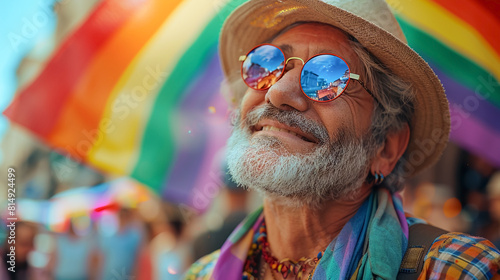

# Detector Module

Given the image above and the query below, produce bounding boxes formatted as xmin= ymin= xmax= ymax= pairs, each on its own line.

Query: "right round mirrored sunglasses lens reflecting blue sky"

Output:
xmin=300 ymin=54 xmax=349 ymax=101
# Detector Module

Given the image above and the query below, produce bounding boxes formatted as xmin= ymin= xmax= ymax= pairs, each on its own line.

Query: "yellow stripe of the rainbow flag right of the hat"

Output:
xmin=387 ymin=0 xmax=500 ymax=79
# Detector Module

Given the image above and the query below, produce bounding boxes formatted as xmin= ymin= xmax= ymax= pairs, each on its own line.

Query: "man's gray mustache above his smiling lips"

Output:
xmin=245 ymin=104 xmax=330 ymax=144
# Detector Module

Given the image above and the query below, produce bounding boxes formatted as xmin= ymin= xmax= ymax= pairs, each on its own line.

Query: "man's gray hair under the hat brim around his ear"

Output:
xmin=348 ymin=36 xmax=415 ymax=192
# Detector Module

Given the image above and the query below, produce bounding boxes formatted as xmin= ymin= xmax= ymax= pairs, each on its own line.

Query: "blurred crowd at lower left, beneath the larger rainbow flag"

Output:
xmin=0 ymin=189 xmax=254 ymax=280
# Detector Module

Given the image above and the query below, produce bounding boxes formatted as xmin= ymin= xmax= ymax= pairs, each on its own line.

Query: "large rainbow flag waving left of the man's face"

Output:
xmin=4 ymin=0 xmax=243 ymax=211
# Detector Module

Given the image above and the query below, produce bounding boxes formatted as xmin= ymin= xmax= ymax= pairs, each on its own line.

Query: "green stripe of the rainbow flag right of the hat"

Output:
xmin=396 ymin=16 xmax=500 ymax=108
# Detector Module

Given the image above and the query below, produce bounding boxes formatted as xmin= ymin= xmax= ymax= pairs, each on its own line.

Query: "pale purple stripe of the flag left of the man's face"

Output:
xmin=163 ymin=51 xmax=230 ymax=211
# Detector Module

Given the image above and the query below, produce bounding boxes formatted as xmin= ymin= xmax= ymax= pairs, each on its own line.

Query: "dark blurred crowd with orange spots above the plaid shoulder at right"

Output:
xmin=403 ymin=144 xmax=500 ymax=248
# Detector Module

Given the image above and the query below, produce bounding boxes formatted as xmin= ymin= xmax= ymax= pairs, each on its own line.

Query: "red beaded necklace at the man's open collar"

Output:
xmin=242 ymin=220 xmax=323 ymax=280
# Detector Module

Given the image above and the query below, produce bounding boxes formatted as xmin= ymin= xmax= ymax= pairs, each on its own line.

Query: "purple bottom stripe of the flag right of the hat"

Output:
xmin=450 ymin=104 xmax=500 ymax=167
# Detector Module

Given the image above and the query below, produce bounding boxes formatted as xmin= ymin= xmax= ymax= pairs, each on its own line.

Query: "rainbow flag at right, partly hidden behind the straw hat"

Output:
xmin=387 ymin=0 xmax=500 ymax=167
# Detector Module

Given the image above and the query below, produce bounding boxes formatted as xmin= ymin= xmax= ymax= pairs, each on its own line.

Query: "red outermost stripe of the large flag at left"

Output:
xmin=4 ymin=0 xmax=145 ymax=138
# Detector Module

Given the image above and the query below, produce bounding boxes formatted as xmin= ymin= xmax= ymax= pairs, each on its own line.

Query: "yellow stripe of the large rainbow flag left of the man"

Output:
xmin=88 ymin=0 xmax=221 ymax=174
